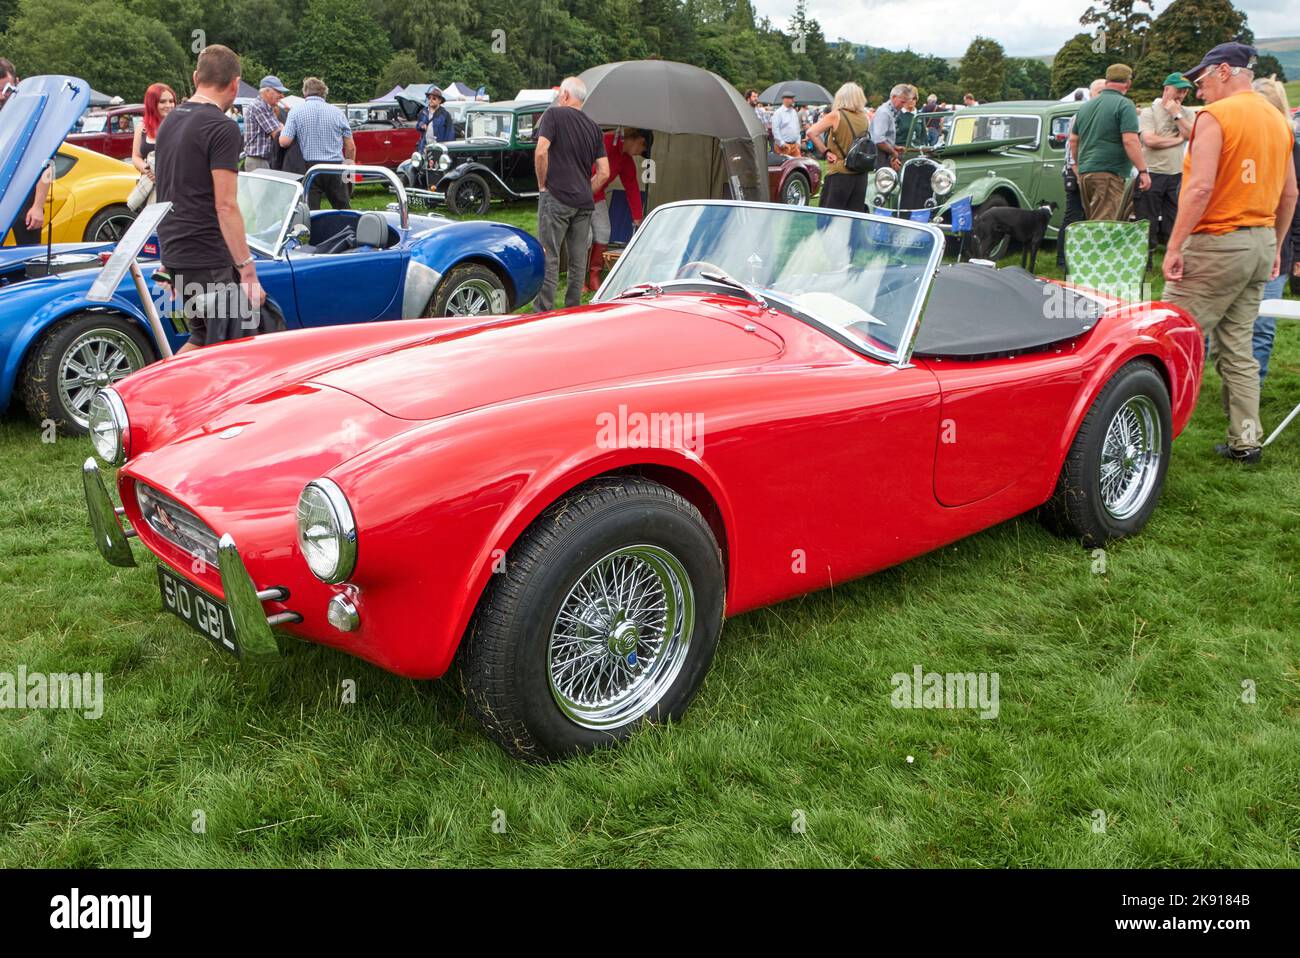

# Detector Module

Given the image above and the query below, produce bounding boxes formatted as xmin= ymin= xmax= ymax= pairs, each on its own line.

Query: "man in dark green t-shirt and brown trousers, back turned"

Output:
xmin=1070 ymin=64 xmax=1151 ymax=220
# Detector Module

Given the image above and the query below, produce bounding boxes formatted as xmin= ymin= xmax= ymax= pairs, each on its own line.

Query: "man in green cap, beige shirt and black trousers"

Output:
xmin=1134 ymin=73 xmax=1196 ymax=250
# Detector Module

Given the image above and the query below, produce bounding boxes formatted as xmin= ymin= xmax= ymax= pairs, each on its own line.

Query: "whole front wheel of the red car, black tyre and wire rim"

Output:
xmin=462 ymin=477 xmax=725 ymax=762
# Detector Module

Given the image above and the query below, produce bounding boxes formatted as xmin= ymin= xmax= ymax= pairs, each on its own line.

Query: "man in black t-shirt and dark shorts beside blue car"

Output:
xmin=155 ymin=44 xmax=265 ymax=352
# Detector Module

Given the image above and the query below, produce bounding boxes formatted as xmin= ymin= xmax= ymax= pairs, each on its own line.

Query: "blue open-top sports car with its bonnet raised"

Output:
xmin=0 ymin=77 xmax=545 ymax=433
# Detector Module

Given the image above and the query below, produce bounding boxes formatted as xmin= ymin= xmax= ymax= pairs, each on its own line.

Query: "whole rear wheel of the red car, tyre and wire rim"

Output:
xmin=1048 ymin=363 xmax=1173 ymax=547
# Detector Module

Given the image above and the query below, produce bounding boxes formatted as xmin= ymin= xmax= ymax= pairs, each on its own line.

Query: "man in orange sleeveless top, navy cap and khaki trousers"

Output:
xmin=1165 ymin=43 xmax=1296 ymax=463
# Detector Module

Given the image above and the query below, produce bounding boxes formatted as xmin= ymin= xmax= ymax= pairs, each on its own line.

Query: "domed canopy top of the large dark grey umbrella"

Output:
xmin=580 ymin=60 xmax=764 ymax=139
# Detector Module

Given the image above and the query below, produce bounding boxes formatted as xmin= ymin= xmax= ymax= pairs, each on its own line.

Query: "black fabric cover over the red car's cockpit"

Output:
xmin=913 ymin=263 xmax=1104 ymax=359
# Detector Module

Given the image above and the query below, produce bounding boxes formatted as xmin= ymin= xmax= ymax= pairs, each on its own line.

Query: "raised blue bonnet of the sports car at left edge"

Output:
xmin=0 ymin=77 xmax=90 ymax=231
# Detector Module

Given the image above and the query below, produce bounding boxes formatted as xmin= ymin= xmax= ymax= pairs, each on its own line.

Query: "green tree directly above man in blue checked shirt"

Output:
xmin=280 ymin=0 xmax=393 ymax=101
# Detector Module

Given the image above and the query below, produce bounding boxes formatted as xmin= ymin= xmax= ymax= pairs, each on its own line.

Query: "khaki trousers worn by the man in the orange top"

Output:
xmin=1165 ymin=226 xmax=1278 ymax=450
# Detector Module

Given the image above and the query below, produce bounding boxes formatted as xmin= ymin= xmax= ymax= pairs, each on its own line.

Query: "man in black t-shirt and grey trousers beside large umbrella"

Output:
xmin=533 ymin=77 xmax=610 ymax=313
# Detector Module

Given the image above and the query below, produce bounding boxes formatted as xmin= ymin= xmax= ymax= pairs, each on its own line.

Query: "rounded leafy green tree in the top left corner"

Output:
xmin=5 ymin=0 xmax=192 ymax=100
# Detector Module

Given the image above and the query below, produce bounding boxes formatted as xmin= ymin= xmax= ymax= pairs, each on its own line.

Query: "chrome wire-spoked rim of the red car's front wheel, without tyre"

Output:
xmin=546 ymin=545 xmax=696 ymax=729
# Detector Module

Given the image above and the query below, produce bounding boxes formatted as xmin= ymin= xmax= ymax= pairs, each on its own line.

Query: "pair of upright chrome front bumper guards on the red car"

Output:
xmin=82 ymin=459 xmax=292 ymax=658
